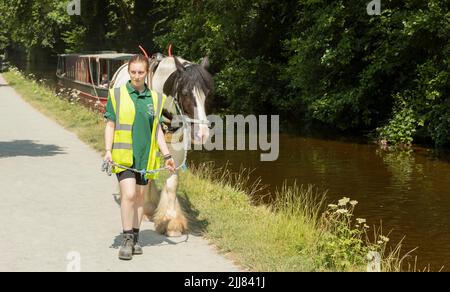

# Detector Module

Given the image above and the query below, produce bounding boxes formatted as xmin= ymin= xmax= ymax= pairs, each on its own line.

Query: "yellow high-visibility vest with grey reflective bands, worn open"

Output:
xmin=109 ymin=85 xmax=166 ymax=179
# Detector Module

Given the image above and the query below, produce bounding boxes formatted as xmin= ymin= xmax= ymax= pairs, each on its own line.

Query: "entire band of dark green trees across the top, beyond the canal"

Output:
xmin=0 ymin=0 xmax=450 ymax=146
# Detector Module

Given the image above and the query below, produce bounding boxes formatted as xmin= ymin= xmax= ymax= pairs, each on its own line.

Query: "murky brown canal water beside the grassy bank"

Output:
xmin=189 ymin=135 xmax=450 ymax=271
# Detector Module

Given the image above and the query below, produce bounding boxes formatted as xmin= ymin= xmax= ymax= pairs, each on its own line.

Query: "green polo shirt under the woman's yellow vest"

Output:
xmin=105 ymin=81 xmax=163 ymax=170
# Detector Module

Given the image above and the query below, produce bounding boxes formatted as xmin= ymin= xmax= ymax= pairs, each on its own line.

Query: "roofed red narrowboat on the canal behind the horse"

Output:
xmin=56 ymin=51 xmax=133 ymax=112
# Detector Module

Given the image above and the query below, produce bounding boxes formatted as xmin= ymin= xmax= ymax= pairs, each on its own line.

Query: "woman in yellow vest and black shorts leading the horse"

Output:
xmin=104 ymin=55 xmax=175 ymax=260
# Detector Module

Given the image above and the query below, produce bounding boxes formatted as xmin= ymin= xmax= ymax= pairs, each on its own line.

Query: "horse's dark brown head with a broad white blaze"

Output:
xmin=164 ymin=57 xmax=214 ymax=144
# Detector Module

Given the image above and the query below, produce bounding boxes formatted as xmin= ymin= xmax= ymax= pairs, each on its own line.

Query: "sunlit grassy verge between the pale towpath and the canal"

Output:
xmin=0 ymin=68 xmax=400 ymax=271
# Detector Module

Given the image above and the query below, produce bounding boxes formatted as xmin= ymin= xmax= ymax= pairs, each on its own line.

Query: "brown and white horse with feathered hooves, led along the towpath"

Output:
xmin=111 ymin=54 xmax=214 ymax=237
